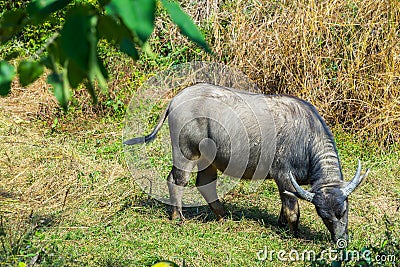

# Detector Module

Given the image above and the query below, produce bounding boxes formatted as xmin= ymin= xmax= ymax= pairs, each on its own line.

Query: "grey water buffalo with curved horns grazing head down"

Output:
xmin=124 ymin=83 xmax=369 ymax=241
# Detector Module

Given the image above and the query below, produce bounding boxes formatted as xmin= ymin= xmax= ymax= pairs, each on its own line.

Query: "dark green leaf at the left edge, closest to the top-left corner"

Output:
xmin=0 ymin=9 xmax=27 ymax=43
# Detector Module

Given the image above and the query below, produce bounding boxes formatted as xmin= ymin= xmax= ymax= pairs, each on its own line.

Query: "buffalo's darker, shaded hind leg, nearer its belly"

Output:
xmin=196 ymin=165 xmax=226 ymax=220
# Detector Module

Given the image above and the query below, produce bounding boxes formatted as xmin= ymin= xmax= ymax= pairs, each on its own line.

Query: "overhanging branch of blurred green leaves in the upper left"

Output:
xmin=0 ymin=0 xmax=211 ymax=111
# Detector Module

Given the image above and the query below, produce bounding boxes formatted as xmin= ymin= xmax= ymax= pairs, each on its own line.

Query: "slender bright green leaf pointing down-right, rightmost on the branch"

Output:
xmin=161 ymin=0 xmax=211 ymax=53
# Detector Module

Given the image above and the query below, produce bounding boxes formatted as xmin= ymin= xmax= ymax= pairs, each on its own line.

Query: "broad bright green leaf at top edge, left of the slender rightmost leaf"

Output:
xmin=106 ymin=0 xmax=156 ymax=43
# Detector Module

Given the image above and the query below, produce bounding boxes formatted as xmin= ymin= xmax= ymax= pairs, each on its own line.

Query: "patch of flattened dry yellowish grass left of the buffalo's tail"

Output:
xmin=0 ymin=79 xmax=133 ymax=265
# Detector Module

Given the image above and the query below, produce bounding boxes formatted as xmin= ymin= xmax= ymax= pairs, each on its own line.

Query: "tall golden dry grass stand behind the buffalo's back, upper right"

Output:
xmin=178 ymin=0 xmax=400 ymax=145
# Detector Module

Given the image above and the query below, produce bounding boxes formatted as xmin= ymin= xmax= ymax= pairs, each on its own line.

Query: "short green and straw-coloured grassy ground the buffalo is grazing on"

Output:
xmin=0 ymin=76 xmax=400 ymax=266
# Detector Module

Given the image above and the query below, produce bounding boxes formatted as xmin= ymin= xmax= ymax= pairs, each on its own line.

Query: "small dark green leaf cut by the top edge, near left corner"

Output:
xmin=27 ymin=0 xmax=71 ymax=23
